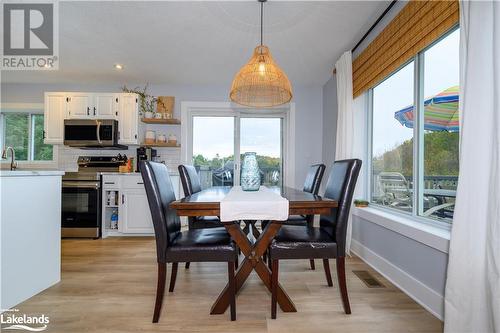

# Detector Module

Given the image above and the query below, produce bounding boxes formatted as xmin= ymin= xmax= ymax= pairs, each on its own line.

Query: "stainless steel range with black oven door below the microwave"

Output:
xmin=61 ymin=154 xmax=127 ymax=238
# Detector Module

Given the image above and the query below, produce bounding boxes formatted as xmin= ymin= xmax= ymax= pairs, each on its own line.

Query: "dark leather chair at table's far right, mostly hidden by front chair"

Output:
xmin=262 ymin=164 xmax=326 ymax=270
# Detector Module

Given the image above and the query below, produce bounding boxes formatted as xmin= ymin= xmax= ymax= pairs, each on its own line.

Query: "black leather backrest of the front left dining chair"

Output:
xmin=141 ymin=161 xmax=181 ymax=262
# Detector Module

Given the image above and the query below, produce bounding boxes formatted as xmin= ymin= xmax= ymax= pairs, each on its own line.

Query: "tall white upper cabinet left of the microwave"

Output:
xmin=43 ymin=92 xmax=67 ymax=144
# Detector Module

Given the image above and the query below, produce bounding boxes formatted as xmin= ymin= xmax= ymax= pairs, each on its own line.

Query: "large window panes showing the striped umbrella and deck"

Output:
xmin=371 ymin=29 xmax=459 ymax=223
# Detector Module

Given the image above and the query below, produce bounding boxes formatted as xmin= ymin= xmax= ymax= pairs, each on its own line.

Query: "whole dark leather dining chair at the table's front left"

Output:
xmin=141 ymin=161 xmax=238 ymax=323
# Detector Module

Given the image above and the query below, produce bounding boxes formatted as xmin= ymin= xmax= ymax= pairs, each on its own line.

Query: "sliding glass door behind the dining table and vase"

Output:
xmin=188 ymin=112 xmax=285 ymax=188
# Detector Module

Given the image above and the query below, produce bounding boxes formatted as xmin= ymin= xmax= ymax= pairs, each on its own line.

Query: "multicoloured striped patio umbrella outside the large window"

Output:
xmin=394 ymin=86 xmax=459 ymax=132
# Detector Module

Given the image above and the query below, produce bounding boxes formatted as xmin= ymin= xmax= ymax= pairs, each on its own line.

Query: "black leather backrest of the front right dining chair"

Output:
xmin=320 ymin=159 xmax=361 ymax=257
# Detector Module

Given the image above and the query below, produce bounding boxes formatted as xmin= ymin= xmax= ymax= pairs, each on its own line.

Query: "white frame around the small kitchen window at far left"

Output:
xmin=0 ymin=103 xmax=58 ymax=163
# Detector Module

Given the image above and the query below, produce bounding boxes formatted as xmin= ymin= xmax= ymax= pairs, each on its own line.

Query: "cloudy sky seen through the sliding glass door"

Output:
xmin=193 ymin=117 xmax=281 ymax=159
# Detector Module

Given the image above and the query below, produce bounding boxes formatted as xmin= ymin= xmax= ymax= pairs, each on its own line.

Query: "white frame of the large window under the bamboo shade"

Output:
xmin=366 ymin=25 xmax=459 ymax=230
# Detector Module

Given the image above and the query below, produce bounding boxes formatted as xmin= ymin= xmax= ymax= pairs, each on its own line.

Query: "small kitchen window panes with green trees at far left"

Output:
xmin=0 ymin=112 xmax=53 ymax=161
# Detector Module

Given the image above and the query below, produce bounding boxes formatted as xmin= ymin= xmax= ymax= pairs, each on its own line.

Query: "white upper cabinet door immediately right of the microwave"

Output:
xmin=118 ymin=94 xmax=140 ymax=145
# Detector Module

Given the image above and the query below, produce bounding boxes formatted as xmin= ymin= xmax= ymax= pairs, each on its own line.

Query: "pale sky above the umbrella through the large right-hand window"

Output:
xmin=373 ymin=29 xmax=460 ymax=156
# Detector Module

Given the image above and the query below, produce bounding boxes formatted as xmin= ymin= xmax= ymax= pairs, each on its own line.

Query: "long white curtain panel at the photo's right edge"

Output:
xmin=444 ymin=1 xmax=500 ymax=333
